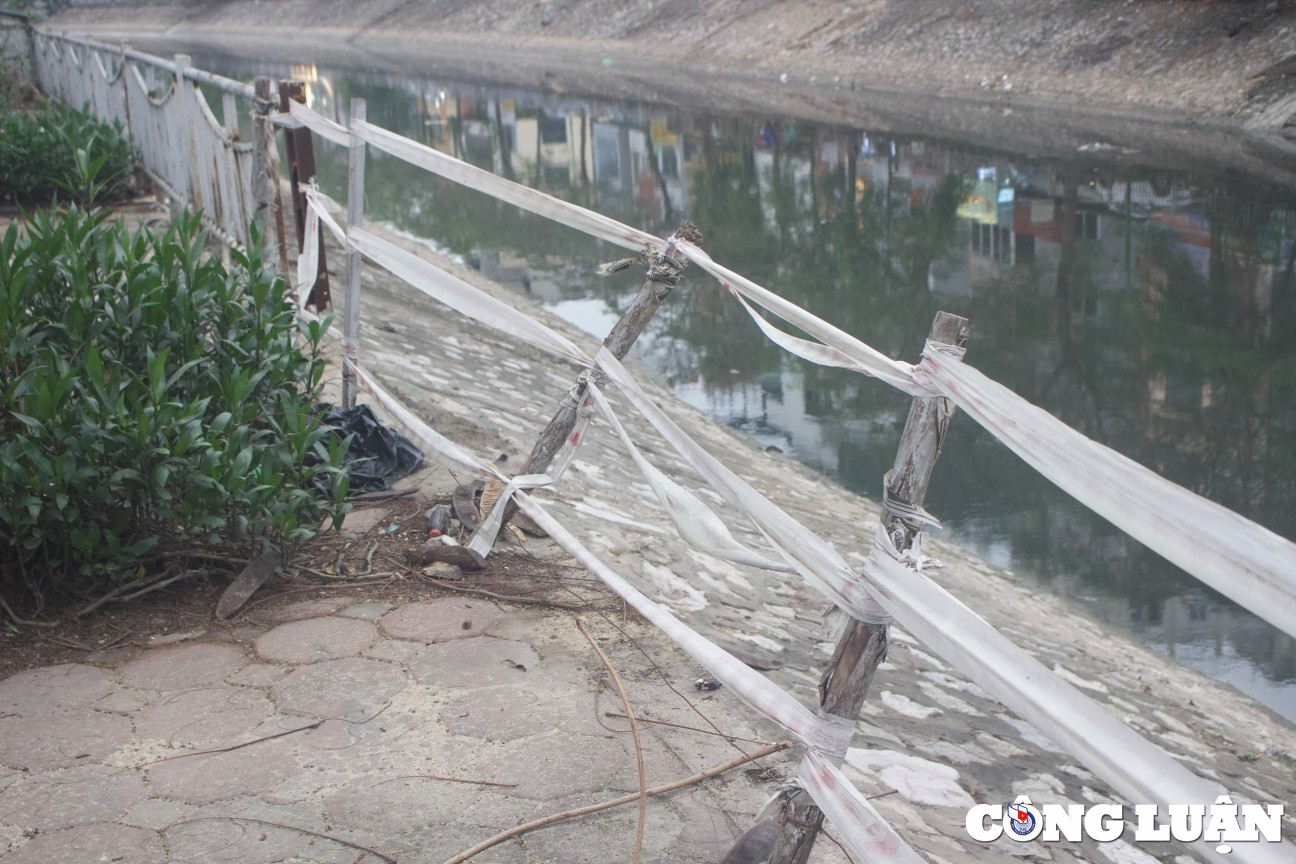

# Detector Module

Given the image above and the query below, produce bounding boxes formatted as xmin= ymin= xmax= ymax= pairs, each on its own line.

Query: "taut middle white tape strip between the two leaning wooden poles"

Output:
xmin=595 ymin=348 xmax=889 ymax=623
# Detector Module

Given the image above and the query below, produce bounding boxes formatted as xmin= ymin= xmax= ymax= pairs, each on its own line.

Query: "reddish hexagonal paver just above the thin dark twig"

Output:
xmin=136 ymin=687 xmax=275 ymax=747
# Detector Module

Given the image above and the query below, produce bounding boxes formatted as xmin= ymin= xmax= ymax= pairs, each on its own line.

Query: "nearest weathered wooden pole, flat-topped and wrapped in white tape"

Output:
xmin=770 ymin=312 xmax=968 ymax=864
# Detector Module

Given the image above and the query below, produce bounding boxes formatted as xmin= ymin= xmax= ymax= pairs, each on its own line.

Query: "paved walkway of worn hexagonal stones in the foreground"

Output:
xmin=0 ymin=597 xmax=789 ymax=864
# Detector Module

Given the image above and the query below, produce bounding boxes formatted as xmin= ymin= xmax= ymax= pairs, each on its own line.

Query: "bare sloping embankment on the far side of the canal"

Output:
xmin=40 ymin=0 xmax=1296 ymax=128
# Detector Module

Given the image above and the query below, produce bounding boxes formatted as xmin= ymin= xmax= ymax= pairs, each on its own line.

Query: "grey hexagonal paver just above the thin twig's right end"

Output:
xmin=272 ymin=657 xmax=410 ymax=720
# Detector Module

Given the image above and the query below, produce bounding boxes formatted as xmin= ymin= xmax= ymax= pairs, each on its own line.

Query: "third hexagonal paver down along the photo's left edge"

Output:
xmin=0 ymin=766 xmax=149 ymax=832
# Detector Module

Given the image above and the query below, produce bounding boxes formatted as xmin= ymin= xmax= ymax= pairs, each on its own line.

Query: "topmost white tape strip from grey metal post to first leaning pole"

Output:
xmin=354 ymin=122 xmax=666 ymax=251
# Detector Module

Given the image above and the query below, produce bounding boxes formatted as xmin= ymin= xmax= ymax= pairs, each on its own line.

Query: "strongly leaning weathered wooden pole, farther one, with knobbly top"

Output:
xmin=495 ymin=222 xmax=702 ymax=522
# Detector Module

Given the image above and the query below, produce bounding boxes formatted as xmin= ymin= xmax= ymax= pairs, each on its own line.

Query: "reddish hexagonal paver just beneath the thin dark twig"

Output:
xmin=148 ymin=738 xmax=299 ymax=804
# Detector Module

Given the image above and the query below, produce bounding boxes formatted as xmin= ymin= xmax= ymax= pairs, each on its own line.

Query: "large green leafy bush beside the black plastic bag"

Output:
xmin=0 ymin=206 xmax=347 ymax=601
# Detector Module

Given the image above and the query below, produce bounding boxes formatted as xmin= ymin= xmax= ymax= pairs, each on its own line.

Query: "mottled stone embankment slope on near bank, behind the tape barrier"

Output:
xmin=330 ymin=222 xmax=1296 ymax=863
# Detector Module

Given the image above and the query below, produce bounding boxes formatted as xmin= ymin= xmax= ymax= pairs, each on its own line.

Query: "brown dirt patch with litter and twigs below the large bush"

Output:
xmin=0 ymin=496 xmax=627 ymax=680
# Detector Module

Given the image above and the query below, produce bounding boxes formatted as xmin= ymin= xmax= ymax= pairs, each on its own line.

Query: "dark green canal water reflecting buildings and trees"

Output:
xmin=194 ymin=54 xmax=1296 ymax=720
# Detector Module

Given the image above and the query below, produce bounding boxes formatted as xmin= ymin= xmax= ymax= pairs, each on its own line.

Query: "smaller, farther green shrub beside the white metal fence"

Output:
xmin=0 ymin=105 xmax=132 ymax=206
